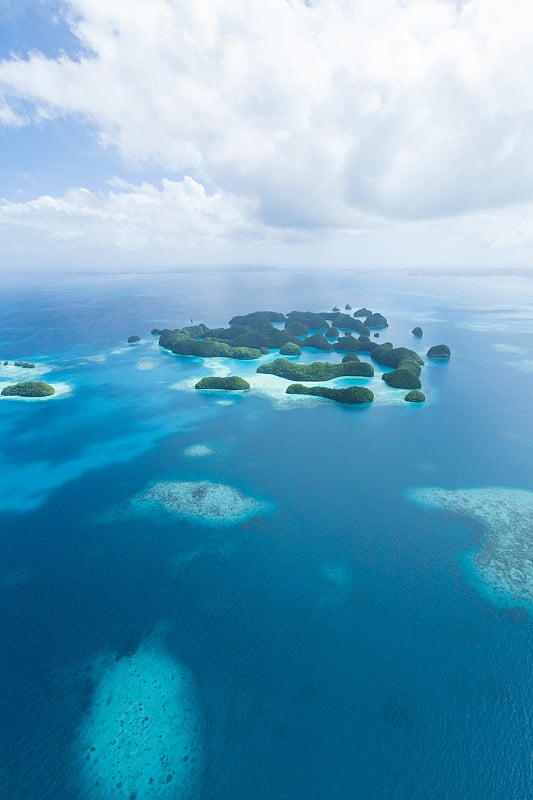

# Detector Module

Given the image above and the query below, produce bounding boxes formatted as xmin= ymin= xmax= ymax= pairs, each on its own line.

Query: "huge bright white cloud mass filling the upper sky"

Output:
xmin=0 ymin=0 xmax=533 ymax=266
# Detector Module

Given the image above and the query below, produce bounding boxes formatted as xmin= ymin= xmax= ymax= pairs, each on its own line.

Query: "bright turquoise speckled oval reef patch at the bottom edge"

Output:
xmin=77 ymin=643 xmax=203 ymax=800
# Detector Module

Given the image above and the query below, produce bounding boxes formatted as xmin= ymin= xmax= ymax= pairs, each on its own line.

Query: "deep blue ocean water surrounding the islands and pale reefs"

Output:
xmin=0 ymin=269 xmax=533 ymax=800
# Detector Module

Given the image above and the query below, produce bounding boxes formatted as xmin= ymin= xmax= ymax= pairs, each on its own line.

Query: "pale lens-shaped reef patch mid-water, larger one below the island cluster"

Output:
xmin=131 ymin=481 xmax=268 ymax=525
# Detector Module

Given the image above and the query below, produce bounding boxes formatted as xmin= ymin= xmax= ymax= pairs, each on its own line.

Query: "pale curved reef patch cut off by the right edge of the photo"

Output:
xmin=407 ymin=487 xmax=533 ymax=605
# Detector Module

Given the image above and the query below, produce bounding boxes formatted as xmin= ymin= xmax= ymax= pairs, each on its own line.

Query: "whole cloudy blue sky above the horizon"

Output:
xmin=0 ymin=0 xmax=533 ymax=271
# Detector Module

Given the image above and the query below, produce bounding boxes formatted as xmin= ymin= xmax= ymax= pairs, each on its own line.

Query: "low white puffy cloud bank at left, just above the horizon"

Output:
xmin=0 ymin=176 xmax=262 ymax=252
